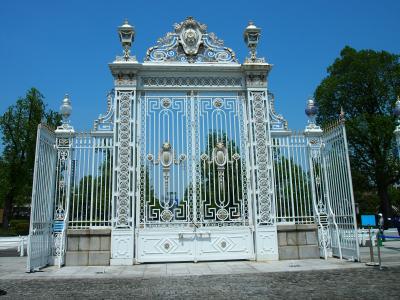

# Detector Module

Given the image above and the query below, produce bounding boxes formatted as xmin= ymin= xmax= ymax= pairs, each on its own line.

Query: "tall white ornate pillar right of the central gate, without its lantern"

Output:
xmin=243 ymin=61 xmax=279 ymax=260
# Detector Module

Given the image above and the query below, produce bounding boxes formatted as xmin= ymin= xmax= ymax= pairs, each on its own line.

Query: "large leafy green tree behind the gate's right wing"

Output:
xmin=315 ymin=46 xmax=400 ymax=224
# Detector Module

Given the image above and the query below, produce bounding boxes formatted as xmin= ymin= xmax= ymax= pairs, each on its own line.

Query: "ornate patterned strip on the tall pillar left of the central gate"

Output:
xmin=116 ymin=92 xmax=133 ymax=227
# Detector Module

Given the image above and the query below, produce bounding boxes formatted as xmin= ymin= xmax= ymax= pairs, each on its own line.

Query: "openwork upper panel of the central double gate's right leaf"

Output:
xmin=196 ymin=95 xmax=249 ymax=226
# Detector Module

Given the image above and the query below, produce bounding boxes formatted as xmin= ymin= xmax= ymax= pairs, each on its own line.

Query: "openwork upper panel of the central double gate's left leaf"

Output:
xmin=139 ymin=95 xmax=193 ymax=227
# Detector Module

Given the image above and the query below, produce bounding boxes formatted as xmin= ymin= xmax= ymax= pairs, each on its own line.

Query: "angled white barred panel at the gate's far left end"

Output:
xmin=27 ymin=125 xmax=57 ymax=272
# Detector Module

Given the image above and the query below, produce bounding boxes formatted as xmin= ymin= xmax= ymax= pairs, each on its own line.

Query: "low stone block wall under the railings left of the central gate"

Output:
xmin=65 ymin=229 xmax=111 ymax=266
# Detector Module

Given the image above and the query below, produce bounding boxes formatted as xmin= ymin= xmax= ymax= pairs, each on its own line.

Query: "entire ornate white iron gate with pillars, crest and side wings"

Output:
xmin=27 ymin=17 xmax=359 ymax=271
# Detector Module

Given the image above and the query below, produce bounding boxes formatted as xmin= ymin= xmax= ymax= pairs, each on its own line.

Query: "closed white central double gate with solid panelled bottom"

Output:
xmin=136 ymin=92 xmax=254 ymax=262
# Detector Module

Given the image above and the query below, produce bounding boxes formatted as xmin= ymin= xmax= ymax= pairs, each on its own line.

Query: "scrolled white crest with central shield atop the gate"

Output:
xmin=145 ymin=17 xmax=237 ymax=63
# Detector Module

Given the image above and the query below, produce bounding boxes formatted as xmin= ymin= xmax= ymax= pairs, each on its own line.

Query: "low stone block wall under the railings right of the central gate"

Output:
xmin=277 ymin=224 xmax=320 ymax=260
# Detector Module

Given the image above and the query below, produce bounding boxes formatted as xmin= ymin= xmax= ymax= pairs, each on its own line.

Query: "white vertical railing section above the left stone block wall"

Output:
xmin=55 ymin=132 xmax=113 ymax=229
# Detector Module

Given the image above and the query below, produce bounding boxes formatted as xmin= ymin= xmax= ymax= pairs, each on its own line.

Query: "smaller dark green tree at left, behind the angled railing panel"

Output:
xmin=0 ymin=88 xmax=61 ymax=228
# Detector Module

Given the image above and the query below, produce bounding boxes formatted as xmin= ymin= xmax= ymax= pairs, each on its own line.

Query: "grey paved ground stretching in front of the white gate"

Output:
xmin=0 ymin=241 xmax=400 ymax=299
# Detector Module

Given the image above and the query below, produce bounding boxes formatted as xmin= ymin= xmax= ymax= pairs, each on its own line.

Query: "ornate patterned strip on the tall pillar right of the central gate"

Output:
xmin=250 ymin=92 xmax=274 ymax=225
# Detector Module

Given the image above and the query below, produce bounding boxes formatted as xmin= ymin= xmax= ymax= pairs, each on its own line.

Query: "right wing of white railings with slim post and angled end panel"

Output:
xmin=272 ymin=117 xmax=359 ymax=260
